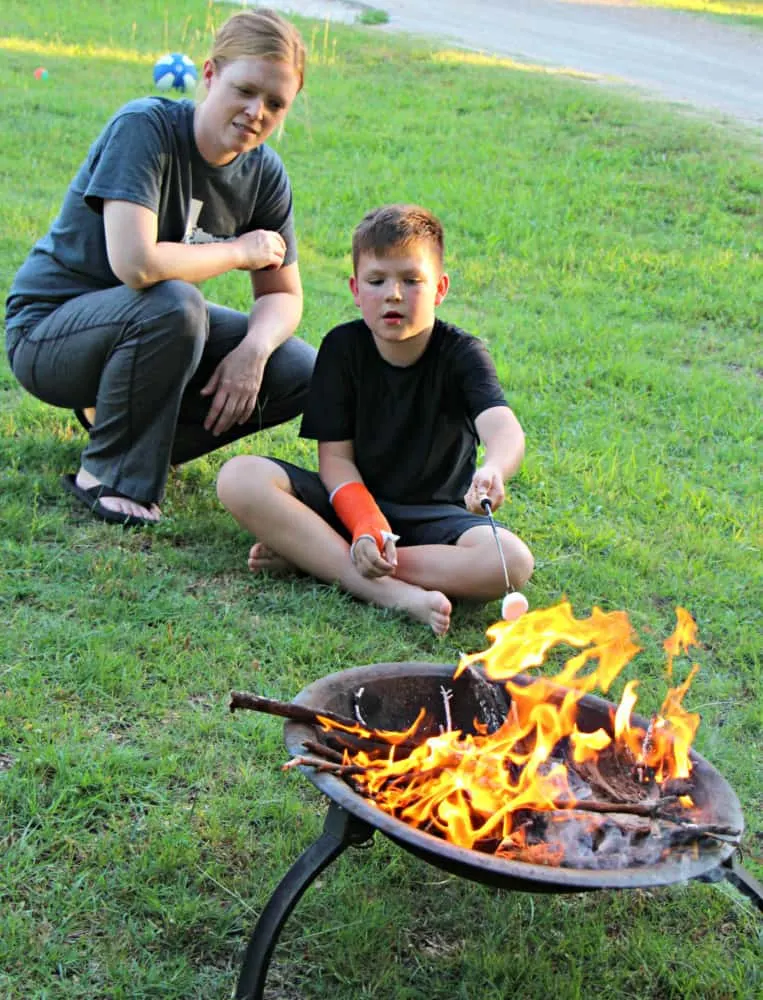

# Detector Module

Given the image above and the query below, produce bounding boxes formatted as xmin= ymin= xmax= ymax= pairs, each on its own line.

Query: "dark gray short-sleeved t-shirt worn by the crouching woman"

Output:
xmin=6 ymin=97 xmax=297 ymax=330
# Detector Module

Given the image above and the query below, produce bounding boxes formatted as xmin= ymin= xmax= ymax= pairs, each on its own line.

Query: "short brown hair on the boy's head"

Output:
xmin=352 ymin=205 xmax=445 ymax=271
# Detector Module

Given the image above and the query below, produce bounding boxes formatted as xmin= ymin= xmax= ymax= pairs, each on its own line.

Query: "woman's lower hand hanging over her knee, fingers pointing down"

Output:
xmin=201 ymin=340 xmax=270 ymax=437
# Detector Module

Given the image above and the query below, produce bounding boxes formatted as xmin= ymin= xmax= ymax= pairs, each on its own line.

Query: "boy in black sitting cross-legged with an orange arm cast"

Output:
xmin=217 ymin=205 xmax=533 ymax=635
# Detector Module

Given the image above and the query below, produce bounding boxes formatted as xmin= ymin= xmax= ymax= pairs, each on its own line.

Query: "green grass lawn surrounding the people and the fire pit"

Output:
xmin=0 ymin=0 xmax=763 ymax=1000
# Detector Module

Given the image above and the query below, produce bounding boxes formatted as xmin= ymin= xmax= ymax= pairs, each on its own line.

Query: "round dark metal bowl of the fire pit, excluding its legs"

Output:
xmin=284 ymin=663 xmax=744 ymax=892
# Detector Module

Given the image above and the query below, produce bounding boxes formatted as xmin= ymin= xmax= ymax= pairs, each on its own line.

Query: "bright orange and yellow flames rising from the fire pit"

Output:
xmin=323 ymin=601 xmax=699 ymax=864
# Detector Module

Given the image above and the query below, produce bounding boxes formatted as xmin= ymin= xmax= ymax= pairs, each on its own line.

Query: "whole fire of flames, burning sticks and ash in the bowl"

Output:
xmin=280 ymin=602 xmax=716 ymax=868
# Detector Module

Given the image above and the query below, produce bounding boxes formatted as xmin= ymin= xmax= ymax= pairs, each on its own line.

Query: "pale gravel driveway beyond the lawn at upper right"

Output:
xmin=264 ymin=0 xmax=763 ymax=129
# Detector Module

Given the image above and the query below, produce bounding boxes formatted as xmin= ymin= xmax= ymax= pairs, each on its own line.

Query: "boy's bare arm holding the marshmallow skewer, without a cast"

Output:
xmin=464 ymin=406 xmax=525 ymax=513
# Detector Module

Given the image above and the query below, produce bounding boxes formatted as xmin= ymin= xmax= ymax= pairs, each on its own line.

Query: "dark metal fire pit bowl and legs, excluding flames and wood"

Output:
xmin=235 ymin=663 xmax=763 ymax=1000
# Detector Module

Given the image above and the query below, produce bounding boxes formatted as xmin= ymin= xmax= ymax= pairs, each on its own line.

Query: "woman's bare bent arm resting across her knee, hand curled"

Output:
xmin=103 ymin=200 xmax=286 ymax=289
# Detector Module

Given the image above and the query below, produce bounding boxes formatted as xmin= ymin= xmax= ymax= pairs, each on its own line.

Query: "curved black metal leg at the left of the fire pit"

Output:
xmin=235 ymin=802 xmax=374 ymax=1000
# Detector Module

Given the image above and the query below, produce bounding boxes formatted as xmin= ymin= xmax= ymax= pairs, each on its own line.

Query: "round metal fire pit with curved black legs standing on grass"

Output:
xmin=236 ymin=663 xmax=763 ymax=1000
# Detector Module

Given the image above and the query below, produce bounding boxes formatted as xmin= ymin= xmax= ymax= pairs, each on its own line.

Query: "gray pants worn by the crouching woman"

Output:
xmin=7 ymin=280 xmax=315 ymax=503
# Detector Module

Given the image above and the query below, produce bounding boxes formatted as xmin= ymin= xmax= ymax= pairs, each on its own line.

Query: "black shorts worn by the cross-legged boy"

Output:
xmin=268 ymin=456 xmax=488 ymax=547
